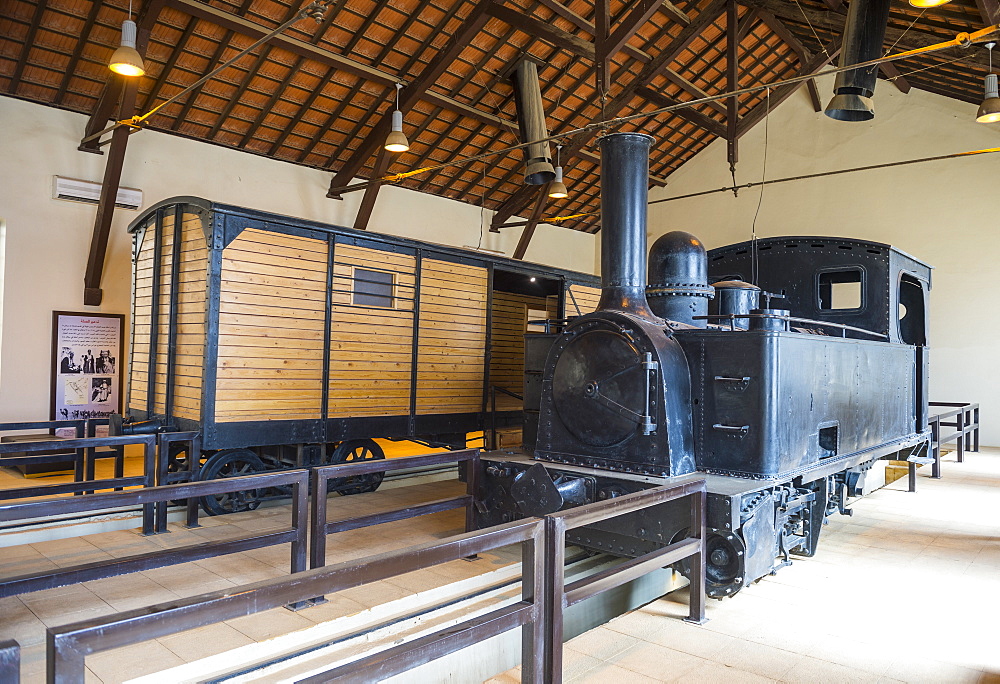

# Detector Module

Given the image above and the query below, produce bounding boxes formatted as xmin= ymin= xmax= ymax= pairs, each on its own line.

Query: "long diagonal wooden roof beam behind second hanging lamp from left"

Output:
xmin=327 ymin=0 xmax=493 ymax=197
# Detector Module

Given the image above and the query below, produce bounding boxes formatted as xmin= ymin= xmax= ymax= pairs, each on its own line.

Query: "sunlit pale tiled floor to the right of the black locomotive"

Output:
xmin=492 ymin=449 xmax=1000 ymax=684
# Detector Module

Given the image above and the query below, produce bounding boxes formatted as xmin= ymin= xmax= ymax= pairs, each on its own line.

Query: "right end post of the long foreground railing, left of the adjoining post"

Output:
xmin=521 ymin=520 xmax=551 ymax=684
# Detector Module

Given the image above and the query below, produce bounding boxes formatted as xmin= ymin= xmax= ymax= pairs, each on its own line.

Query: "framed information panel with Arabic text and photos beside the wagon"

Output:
xmin=51 ymin=311 xmax=125 ymax=420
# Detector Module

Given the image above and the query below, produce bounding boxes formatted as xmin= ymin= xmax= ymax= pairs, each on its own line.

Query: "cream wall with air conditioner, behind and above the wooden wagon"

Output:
xmin=0 ymin=97 xmax=596 ymax=421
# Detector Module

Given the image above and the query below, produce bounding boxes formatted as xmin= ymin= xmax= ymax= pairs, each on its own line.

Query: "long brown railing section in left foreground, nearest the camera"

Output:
xmin=46 ymin=520 xmax=545 ymax=684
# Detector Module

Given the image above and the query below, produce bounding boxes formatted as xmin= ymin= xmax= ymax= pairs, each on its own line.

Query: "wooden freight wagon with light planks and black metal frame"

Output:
xmin=126 ymin=197 xmax=600 ymax=512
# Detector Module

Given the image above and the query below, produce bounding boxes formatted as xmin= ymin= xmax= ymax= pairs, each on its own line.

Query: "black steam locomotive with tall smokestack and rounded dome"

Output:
xmin=480 ymin=133 xmax=930 ymax=598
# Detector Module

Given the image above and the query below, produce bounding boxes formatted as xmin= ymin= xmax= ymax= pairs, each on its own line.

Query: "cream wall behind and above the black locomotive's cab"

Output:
xmin=649 ymin=76 xmax=1000 ymax=445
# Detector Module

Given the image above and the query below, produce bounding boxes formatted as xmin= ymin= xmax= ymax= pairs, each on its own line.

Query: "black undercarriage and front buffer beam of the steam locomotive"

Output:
xmin=477 ymin=435 xmax=926 ymax=599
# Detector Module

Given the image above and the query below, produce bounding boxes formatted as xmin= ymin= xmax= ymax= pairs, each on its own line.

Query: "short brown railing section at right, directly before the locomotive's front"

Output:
xmin=545 ymin=477 xmax=707 ymax=684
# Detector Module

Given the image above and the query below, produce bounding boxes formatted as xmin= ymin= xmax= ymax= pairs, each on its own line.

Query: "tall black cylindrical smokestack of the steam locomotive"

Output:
xmin=597 ymin=133 xmax=653 ymax=316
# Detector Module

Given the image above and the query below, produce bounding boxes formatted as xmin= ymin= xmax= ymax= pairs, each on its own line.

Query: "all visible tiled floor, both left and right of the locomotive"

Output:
xmin=0 ymin=449 xmax=1000 ymax=684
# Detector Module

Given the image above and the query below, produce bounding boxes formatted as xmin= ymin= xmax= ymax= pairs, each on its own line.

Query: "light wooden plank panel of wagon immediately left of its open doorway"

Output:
xmin=416 ymin=258 xmax=489 ymax=433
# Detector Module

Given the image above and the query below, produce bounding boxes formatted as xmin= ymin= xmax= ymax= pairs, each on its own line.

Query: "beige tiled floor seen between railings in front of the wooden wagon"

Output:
xmin=0 ymin=481 xmax=520 ymax=683
